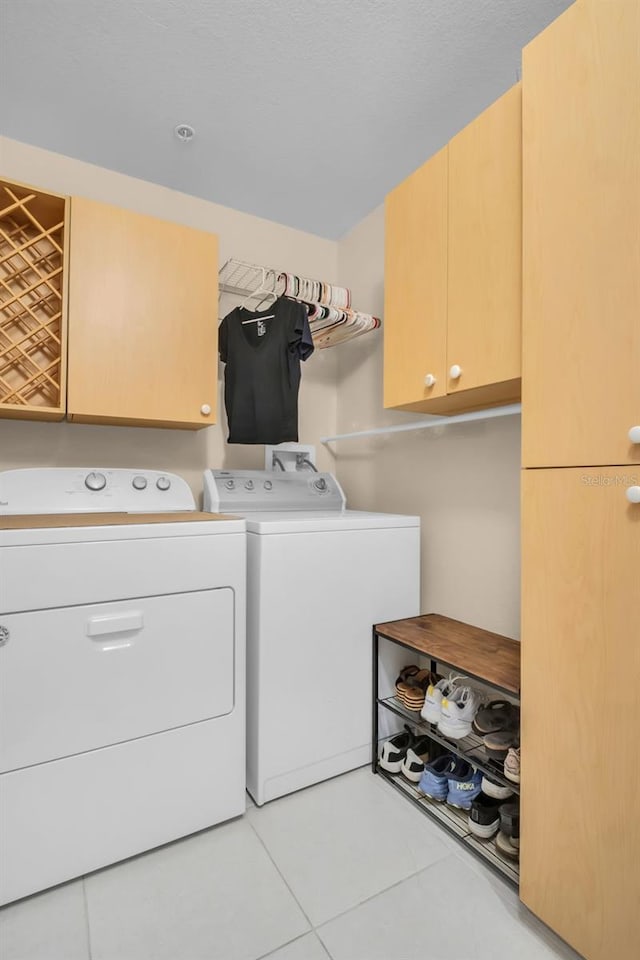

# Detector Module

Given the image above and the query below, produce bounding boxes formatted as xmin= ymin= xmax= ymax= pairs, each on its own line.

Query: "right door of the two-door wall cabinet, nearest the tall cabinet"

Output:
xmin=447 ymin=84 xmax=522 ymax=399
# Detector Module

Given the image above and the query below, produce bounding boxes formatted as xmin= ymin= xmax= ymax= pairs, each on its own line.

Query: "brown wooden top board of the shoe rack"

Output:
xmin=375 ymin=613 xmax=520 ymax=694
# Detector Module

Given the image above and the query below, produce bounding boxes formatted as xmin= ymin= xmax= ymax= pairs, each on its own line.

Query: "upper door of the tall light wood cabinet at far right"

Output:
xmin=522 ymin=0 xmax=640 ymax=466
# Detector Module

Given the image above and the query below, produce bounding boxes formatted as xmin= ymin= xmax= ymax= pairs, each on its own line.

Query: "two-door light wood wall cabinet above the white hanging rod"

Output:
xmin=384 ymin=84 xmax=522 ymax=414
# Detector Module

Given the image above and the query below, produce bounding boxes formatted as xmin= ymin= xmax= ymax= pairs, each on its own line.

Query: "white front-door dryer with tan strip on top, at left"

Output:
xmin=0 ymin=469 xmax=246 ymax=903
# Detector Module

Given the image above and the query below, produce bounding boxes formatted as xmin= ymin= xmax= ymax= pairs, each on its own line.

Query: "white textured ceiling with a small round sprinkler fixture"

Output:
xmin=0 ymin=0 xmax=571 ymax=238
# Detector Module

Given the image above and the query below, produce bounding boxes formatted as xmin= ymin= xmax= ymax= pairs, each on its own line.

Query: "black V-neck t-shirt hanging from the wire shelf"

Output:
xmin=219 ymin=297 xmax=313 ymax=444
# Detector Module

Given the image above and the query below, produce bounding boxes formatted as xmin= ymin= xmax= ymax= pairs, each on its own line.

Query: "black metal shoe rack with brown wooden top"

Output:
xmin=371 ymin=613 xmax=520 ymax=887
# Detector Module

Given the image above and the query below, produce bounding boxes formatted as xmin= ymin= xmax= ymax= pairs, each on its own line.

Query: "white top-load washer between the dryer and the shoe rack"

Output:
xmin=204 ymin=470 xmax=420 ymax=805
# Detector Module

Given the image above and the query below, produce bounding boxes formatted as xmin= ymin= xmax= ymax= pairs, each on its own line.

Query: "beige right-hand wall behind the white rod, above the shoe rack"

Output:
xmin=334 ymin=207 xmax=520 ymax=637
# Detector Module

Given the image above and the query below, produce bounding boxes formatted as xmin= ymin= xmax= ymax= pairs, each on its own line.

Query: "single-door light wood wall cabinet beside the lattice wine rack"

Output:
xmin=67 ymin=197 xmax=218 ymax=429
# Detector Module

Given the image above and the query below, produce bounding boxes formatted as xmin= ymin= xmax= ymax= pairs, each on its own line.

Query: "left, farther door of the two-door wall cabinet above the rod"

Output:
xmin=384 ymin=147 xmax=447 ymax=409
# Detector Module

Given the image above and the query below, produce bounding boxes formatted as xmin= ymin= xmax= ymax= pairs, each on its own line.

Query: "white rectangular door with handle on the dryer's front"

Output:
xmin=0 ymin=587 xmax=234 ymax=772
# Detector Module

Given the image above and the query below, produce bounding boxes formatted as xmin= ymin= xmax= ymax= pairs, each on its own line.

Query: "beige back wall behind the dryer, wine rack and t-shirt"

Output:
xmin=0 ymin=138 xmax=337 ymax=502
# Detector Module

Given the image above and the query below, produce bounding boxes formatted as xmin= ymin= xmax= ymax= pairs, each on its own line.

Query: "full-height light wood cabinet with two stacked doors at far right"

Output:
xmin=520 ymin=0 xmax=640 ymax=960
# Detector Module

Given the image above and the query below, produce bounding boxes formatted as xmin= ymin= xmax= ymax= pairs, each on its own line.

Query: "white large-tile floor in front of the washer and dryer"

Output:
xmin=0 ymin=768 xmax=577 ymax=960
